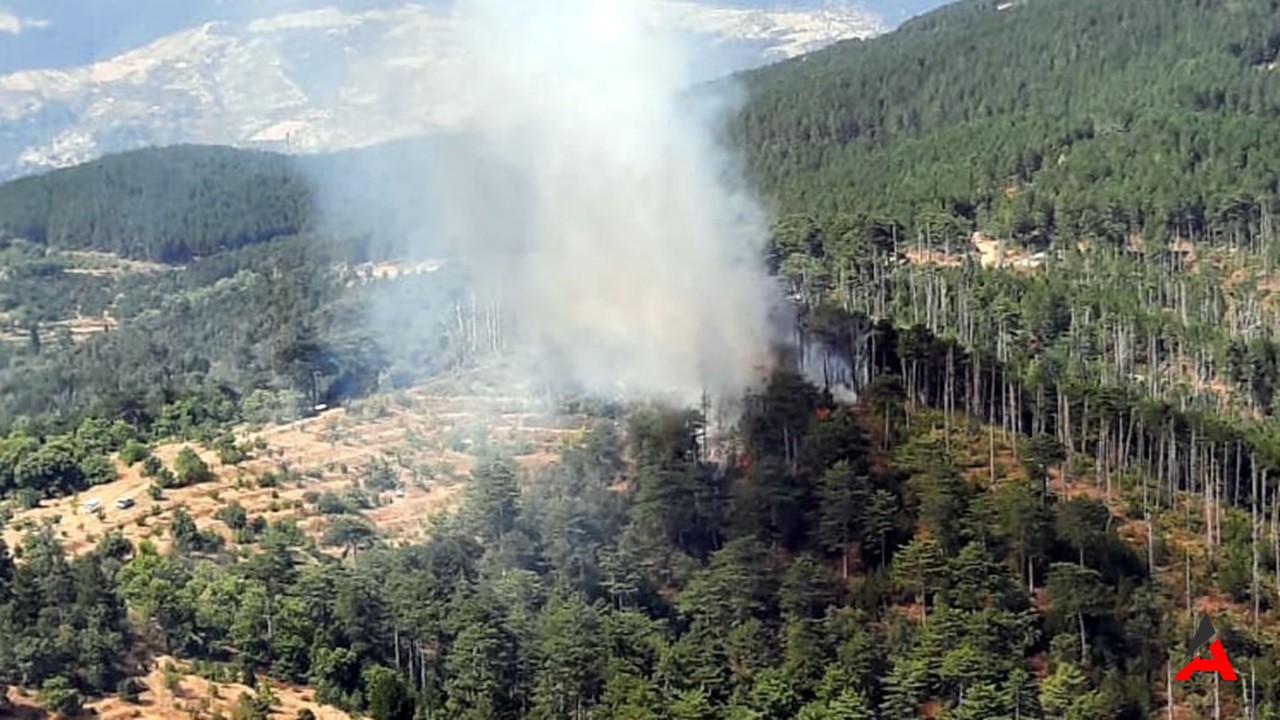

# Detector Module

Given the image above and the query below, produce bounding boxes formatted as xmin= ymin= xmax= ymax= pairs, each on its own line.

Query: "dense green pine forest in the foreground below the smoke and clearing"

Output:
xmin=0 ymin=373 xmax=1218 ymax=720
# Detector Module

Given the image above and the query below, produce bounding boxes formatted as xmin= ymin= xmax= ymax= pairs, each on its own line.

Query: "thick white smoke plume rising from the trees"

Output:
xmin=424 ymin=0 xmax=773 ymax=402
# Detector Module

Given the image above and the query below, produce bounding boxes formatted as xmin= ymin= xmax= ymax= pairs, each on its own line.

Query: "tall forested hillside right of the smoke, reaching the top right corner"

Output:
xmin=735 ymin=0 xmax=1280 ymax=717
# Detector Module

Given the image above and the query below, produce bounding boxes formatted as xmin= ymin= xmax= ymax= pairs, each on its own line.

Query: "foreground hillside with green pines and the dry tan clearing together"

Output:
xmin=0 ymin=358 xmax=1280 ymax=720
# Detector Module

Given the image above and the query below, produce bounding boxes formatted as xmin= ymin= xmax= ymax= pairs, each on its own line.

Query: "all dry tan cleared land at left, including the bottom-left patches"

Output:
xmin=0 ymin=379 xmax=588 ymax=720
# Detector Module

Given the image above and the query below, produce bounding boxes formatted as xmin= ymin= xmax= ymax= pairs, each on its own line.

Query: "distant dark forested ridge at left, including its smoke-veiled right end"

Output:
xmin=0 ymin=135 xmax=465 ymax=264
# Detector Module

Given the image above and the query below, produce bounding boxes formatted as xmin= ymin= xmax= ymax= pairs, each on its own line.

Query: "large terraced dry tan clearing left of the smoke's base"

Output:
xmin=4 ymin=392 xmax=586 ymax=553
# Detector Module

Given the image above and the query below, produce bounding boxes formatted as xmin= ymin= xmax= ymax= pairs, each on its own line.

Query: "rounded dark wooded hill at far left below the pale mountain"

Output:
xmin=0 ymin=146 xmax=315 ymax=263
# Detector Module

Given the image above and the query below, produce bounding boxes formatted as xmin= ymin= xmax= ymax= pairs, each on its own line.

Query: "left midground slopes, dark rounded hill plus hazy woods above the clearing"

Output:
xmin=0 ymin=141 xmax=497 ymax=430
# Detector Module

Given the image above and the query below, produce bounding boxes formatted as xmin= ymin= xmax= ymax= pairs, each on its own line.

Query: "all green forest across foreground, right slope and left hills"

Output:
xmin=0 ymin=0 xmax=1280 ymax=720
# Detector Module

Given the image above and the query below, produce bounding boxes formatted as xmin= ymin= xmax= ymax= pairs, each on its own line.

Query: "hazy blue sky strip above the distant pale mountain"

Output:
xmin=0 ymin=0 xmax=943 ymax=73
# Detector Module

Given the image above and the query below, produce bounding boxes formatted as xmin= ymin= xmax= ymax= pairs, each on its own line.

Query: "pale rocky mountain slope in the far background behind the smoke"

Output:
xmin=0 ymin=3 xmax=883 ymax=178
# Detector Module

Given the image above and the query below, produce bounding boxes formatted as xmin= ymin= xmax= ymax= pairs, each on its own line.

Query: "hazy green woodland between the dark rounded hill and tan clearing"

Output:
xmin=0 ymin=236 xmax=466 ymax=429
